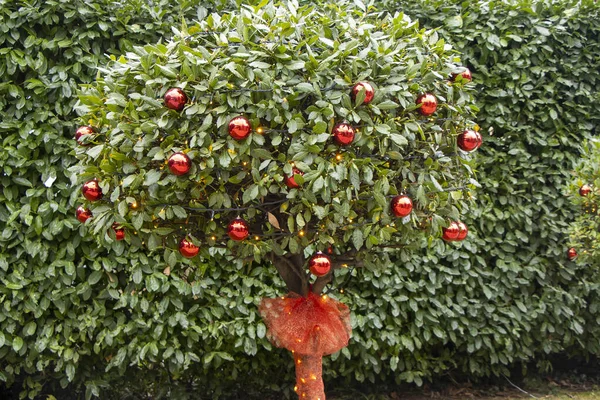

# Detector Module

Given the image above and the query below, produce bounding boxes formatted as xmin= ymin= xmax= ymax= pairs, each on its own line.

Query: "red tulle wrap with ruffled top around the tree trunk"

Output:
xmin=258 ymin=293 xmax=352 ymax=400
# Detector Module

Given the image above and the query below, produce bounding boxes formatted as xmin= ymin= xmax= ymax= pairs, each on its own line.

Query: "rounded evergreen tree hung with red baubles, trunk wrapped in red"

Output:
xmin=73 ymin=1 xmax=481 ymax=399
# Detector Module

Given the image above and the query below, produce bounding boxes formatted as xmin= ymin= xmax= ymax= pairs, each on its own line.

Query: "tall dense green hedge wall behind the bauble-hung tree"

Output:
xmin=0 ymin=0 xmax=600 ymax=398
